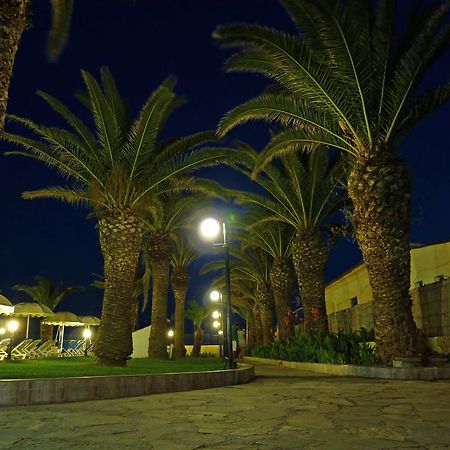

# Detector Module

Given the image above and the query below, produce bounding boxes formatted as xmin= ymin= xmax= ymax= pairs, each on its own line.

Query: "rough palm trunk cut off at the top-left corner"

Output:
xmin=0 ymin=0 xmax=31 ymax=135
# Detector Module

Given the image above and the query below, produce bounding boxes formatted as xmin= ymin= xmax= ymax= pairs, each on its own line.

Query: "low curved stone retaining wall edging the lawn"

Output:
xmin=0 ymin=365 xmax=255 ymax=406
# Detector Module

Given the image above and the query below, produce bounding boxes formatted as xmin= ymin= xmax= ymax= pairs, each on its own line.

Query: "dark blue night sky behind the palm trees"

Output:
xmin=0 ymin=0 xmax=450 ymax=325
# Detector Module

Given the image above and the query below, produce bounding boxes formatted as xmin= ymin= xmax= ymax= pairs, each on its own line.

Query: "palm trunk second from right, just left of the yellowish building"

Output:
xmin=292 ymin=228 xmax=328 ymax=333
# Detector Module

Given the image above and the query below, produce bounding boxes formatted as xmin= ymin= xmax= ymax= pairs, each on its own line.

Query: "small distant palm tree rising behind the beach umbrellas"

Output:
xmin=13 ymin=275 xmax=84 ymax=341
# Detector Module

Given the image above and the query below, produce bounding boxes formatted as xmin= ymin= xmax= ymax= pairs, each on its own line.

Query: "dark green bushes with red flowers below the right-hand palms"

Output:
xmin=251 ymin=328 xmax=377 ymax=366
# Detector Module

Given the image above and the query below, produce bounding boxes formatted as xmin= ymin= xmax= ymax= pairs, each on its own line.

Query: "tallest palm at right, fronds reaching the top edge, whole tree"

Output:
xmin=215 ymin=0 xmax=450 ymax=363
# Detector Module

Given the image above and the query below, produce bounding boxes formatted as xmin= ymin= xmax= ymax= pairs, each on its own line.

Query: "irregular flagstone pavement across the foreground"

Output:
xmin=0 ymin=365 xmax=450 ymax=450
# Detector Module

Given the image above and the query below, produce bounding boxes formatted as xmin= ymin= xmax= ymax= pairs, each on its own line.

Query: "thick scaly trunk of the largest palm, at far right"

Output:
xmin=348 ymin=152 xmax=420 ymax=364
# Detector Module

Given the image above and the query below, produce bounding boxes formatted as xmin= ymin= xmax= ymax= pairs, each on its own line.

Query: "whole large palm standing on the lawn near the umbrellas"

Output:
xmin=4 ymin=68 xmax=226 ymax=365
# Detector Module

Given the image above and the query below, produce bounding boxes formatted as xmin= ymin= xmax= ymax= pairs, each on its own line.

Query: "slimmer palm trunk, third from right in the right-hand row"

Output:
xmin=270 ymin=257 xmax=293 ymax=339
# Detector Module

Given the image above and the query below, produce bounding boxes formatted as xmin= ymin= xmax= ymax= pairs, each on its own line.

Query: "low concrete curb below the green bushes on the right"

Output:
xmin=245 ymin=357 xmax=450 ymax=381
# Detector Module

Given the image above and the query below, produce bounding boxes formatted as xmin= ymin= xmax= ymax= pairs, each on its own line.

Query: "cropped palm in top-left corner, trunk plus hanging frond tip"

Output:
xmin=0 ymin=0 xmax=73 ymax=135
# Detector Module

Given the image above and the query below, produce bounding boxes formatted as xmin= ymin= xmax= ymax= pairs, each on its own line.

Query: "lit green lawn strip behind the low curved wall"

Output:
xmin=0 ymin=356 xmax=224 ymax=379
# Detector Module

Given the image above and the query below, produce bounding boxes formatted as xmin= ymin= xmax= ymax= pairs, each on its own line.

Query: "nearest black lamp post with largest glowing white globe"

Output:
xmin=200 ymin=218 xmax=236 ymax=369
